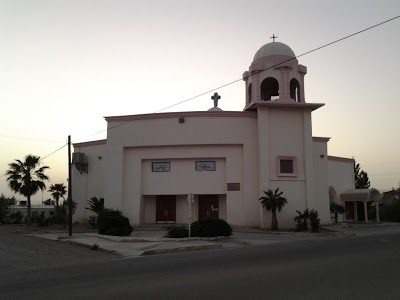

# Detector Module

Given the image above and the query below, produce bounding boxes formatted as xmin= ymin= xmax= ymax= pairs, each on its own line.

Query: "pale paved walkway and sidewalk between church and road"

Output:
xmin=25 ymin=223 xmax=400 ymax=257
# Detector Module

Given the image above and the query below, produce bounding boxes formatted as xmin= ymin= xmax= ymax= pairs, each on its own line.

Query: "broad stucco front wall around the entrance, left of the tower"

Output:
xmin=105 ymin=112 xmax=259 ymax=226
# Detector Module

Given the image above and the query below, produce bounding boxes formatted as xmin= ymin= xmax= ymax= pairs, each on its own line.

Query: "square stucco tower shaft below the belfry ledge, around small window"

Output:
xmin=258 ymin=108 xmax=314 ymax=228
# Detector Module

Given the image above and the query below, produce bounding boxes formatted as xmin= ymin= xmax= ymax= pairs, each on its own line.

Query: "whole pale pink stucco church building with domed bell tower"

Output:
xmin=72 ymin=42 xmax=354 ymax=228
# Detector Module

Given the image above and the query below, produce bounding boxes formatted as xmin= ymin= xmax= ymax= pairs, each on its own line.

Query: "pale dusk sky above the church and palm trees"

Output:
xmin=0 ymin=0 xmax=400 ymax=203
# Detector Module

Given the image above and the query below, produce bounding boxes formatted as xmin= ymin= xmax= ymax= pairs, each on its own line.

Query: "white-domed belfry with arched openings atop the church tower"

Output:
xmin=243 ymin=36 xmax=307 ymax=110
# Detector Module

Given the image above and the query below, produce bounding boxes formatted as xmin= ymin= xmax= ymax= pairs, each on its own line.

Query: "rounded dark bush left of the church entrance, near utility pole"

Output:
xmin=97 ymin=208 xmax=133 ymax=236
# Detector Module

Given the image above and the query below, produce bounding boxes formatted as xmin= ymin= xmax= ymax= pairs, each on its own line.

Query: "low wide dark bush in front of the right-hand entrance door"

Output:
xmin=191 ymin=219 xmax=232 ymax=237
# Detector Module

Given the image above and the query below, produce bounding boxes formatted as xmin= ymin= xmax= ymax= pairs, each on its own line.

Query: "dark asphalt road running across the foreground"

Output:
xmin=0 ymin=233 xmax=400 ymax=299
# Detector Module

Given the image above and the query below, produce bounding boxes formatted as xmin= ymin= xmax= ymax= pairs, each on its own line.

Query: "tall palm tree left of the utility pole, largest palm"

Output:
xmin=6 ymin=154 xmax=50 ymax=225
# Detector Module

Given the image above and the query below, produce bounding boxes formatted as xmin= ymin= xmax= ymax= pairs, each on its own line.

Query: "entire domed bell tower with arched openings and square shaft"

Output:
xmin=243 ymin=36 xmax=329 ymax=227
